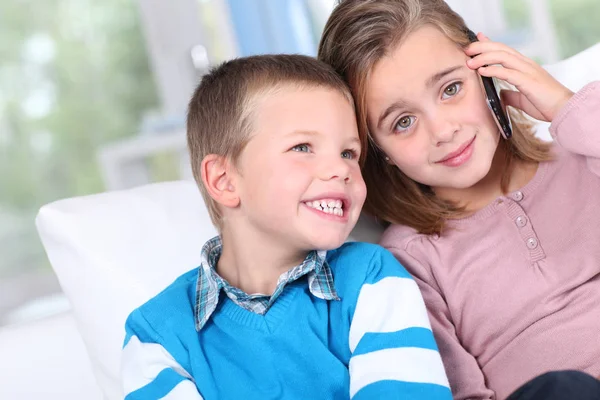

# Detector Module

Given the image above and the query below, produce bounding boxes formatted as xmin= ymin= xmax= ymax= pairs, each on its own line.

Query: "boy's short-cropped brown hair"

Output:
xmin=187 ymin=54 xmax=354 ymax=230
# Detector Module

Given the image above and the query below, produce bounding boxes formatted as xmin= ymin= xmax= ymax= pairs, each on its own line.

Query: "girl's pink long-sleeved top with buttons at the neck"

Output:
xmin=381 ymin=82 xmax=600 ymax=399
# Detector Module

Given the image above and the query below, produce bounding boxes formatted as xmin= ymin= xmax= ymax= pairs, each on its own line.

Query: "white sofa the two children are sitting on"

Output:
xmin=0 ymin=44 xmax=600 ymax=400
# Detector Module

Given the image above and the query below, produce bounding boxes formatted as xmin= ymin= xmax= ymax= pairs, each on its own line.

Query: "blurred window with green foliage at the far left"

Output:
xmin=0 ymin=0 xmax=159 ymax=325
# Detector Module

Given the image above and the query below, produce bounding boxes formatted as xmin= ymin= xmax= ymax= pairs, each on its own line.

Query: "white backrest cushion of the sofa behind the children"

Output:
xmin=37 ymin=44 xmax=600 ymax=400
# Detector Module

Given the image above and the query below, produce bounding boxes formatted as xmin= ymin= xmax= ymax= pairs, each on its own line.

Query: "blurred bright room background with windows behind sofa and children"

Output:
xmin=0 ymin=0 xmax=600 ymax=330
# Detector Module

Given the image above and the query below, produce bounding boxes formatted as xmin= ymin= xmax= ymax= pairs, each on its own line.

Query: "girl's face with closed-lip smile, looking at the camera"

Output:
xmin=367 ymin=25 xmax=500 ymax=198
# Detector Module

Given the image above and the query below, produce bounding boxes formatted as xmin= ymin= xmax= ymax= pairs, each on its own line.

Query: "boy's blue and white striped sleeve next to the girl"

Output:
xmin=349 ymin=249 xmax=452 ymax=400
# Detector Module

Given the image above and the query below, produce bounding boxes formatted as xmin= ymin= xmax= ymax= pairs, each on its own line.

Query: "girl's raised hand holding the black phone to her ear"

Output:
xmin=465 ymin=33 xmax=573 ymax=122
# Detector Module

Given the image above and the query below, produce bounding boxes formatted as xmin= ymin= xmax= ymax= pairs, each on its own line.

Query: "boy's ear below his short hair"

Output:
xmin=201 ymin=154 xmax=240 ymax=208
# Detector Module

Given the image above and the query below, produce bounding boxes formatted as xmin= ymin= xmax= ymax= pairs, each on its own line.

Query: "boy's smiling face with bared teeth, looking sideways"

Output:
xmin=236 ymin=87 xmax=366 ymax=251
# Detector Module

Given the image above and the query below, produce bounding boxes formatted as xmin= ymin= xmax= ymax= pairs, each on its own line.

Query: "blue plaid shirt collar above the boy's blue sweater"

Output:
xmin=195 ymin=236 xmax=340 ymax=331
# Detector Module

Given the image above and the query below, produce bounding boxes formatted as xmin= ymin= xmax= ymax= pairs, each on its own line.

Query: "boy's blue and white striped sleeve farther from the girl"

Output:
xmin=121 ymin=310 xmax=203 ymax=400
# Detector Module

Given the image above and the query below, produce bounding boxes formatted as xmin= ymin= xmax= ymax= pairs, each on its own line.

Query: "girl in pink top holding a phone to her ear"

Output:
xmin=319 ymin=0 xmax=600 ymax=399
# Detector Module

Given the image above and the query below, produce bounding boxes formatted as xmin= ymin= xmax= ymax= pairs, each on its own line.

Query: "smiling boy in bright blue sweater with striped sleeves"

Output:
xmin=122 ymin=55 xmax=451 ymax=400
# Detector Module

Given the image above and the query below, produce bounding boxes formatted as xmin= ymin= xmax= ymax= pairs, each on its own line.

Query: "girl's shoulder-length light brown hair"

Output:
xmin=318 ymin=0 xmax=551 ymax=234
